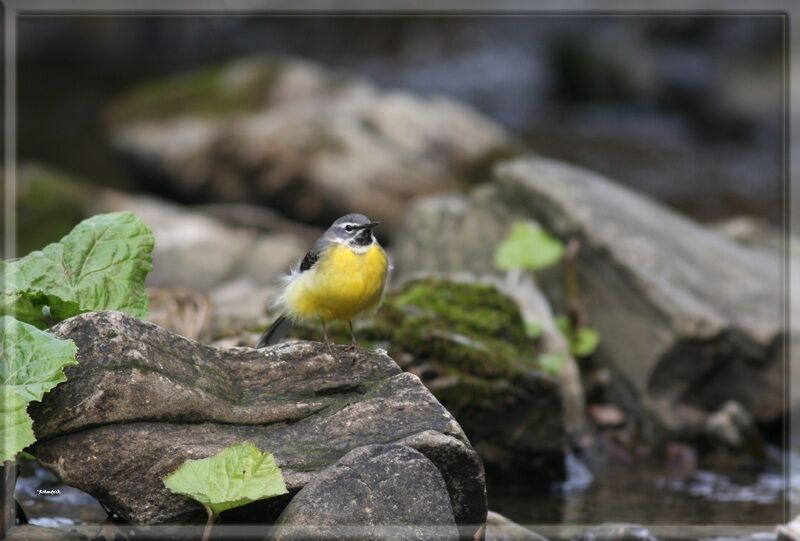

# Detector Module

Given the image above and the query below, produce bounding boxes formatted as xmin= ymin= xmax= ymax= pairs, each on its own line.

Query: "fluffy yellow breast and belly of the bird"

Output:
xmin=283 ymin=244 xmax=388 ymax=321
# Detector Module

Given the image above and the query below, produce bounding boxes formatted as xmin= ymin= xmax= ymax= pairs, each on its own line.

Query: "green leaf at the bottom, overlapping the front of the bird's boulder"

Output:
xmin=163 ymin=443 xmax=287 ymax=516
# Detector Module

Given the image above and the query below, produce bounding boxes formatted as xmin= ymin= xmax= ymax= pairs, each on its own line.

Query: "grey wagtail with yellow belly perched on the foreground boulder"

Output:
xmin=256 ymin=214 xmax=389 ymax=354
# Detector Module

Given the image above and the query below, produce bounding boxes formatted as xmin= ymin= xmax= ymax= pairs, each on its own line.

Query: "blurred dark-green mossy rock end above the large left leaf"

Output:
xmin=17 ymin=165 xmax=95 ymax=256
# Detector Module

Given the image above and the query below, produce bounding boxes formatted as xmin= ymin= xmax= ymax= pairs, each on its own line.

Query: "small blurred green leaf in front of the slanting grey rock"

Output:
xmin=494 ymin=222 xmax=564 ymax=271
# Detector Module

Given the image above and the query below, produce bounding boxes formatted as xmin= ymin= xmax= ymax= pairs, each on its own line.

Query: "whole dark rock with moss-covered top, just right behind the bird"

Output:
xmin=294 ymin=277 xmax=566 ymax=487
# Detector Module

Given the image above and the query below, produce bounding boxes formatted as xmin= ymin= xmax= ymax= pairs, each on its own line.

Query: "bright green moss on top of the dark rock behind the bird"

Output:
xmin=293 ymin=279 xmax=540 ymax=380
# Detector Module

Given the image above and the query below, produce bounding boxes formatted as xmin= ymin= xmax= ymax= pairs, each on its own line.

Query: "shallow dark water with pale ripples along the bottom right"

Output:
xmin=489 ymin=456 xmax=790 ymax=525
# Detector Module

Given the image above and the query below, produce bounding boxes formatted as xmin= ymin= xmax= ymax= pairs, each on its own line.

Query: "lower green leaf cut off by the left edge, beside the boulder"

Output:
xmin=0 ymin=316 xmax=77 ymax=460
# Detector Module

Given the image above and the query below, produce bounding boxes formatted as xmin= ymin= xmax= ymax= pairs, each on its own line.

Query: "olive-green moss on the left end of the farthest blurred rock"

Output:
xmin=108 ymin=60 xmax=282 ymax=123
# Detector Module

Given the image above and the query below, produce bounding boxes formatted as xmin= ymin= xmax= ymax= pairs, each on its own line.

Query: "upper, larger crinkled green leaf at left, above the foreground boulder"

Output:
xmin=0 ymin=212 xmax=155 ymax=328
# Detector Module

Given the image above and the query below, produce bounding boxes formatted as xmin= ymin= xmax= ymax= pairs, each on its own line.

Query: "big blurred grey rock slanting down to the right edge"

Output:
xmin=496 ymin=158 xmax=795 ymax=435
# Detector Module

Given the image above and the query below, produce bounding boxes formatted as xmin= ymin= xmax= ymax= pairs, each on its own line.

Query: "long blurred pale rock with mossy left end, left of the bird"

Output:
xmin=18 ymin=165 xmax=314 ymax=293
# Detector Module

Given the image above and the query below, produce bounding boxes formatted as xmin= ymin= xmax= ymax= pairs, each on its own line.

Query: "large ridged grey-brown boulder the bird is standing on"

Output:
xmin=30 ymin=312 xmax=486 ymax=531
